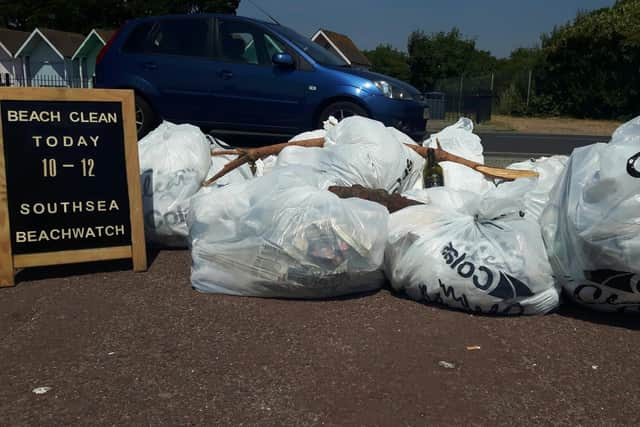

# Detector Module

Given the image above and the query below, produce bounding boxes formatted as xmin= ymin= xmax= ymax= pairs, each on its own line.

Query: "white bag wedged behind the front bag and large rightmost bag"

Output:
xmin=498 ymin=156 xmax=569 ymax=221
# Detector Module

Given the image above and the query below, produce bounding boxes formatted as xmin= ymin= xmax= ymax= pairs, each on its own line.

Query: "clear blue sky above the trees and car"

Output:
xmin=237 ymin=0 xmax=615 ymax=58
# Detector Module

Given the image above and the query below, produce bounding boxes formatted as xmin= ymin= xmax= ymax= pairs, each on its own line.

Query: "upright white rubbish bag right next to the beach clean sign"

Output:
xmin=138 ymin=122 xmax=211 ymax=246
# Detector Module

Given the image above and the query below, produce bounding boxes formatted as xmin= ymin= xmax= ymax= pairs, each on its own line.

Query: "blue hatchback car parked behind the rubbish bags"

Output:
xmin=95 ymin=14 xmax=427 ymax=139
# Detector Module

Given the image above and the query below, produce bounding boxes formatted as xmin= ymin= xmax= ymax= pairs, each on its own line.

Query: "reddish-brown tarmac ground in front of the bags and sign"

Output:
xmin=0 ymin=251 xmax=640 ymax=426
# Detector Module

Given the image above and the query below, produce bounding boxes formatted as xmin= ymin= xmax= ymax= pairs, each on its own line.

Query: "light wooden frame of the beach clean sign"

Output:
xmin=0 ymin=88 xmax=147 ymax=287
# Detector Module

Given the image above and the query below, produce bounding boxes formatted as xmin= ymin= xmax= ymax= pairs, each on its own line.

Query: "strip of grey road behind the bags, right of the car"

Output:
xmin=478 ymin=132 xmax=609 ymax=157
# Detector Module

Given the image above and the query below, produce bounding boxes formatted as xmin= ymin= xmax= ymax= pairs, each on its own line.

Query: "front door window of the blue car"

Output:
xmin=218 ymin=20 xmax=284 ymax=65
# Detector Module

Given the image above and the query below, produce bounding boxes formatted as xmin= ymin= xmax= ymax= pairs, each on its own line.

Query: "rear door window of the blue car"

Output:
xmin=148 ymin=18 xmax=210 ymax=57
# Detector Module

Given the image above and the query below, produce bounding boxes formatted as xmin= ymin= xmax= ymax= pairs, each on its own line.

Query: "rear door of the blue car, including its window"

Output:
xmin=124 ymin=16 xmax=217 ymax=125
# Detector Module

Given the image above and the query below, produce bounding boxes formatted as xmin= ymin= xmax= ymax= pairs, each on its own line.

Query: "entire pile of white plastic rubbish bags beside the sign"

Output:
xmin=139 ymin=117 xmax=640 ymax=315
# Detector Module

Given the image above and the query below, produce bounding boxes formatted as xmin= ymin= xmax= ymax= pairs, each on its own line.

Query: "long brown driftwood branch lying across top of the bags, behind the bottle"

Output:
xmin=202 ymin=138 xmax=538 ymax=187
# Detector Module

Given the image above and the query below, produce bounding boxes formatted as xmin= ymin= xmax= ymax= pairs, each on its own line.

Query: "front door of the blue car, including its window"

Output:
xmin=213 ymin=18 xmax=313 ymax=133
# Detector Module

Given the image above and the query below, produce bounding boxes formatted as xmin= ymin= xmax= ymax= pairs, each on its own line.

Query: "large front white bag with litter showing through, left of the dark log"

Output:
xmin=188 ymin=167 xmax=389 ymax=298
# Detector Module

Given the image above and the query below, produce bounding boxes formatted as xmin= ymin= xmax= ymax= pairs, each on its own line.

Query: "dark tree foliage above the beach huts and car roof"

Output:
xmin=0 ymin=0 xmax=240 ymax=34
